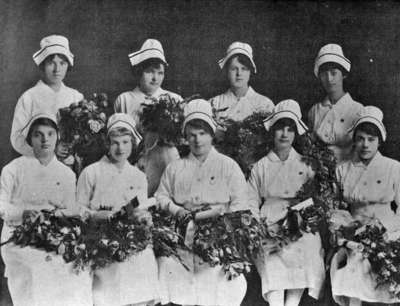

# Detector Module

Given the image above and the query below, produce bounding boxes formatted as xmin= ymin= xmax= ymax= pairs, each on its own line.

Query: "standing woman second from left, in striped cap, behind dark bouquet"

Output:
xmin=114 ymin=39 xmax=182 ymax=196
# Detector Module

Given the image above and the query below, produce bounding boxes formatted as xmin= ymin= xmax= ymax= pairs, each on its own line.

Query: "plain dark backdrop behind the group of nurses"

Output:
xmin=0 ymin=0 xmax=400 ymax=305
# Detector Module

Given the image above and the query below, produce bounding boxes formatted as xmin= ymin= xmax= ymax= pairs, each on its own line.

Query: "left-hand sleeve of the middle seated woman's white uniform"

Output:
xmin=155 ymin=166 xmax=182 ymax=214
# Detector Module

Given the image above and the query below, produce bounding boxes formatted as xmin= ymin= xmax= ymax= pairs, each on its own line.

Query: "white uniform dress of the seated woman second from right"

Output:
xmin=248 ymin=148 xmax=325 ymax=299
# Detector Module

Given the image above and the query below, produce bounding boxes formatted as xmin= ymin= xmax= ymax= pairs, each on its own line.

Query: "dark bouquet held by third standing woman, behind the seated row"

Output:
xmin=215 ymin=113 xmax=272 ymax=177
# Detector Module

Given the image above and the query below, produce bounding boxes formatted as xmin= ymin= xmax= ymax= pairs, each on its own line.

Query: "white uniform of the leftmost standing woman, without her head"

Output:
xmin=10 ymin=81 xmax=83 ymax=156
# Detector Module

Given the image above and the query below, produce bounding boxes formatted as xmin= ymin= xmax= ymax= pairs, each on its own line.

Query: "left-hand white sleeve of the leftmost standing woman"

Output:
xmin=10 ymin=94 xmax=33 ymax=156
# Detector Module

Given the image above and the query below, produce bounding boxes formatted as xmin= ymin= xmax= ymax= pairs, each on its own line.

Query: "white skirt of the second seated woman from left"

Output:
xmin=93 ymin=247 xmax=159 ymax=306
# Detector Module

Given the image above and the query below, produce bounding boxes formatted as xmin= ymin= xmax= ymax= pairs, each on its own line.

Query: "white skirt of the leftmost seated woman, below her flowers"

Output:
xmin=1 ymin=224 xmax=93 ymax=306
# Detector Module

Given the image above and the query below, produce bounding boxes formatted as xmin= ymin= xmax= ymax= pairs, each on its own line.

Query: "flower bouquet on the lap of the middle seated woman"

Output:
xmin=193 ymin=211 xmax=264 ymax=279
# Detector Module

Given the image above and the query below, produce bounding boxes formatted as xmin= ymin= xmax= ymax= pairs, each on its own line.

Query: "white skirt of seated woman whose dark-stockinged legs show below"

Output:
xmin=254 ymin=233 xmax=325 ymax=300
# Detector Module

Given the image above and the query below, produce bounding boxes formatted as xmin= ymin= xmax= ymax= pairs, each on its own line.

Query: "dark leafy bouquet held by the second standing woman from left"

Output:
xmin=140 ymin=94 xmax=192 ymax=155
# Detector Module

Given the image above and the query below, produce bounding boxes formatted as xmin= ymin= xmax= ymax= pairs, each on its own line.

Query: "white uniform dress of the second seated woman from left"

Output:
xmin=77 ymin=156 xmax=158 ymax=306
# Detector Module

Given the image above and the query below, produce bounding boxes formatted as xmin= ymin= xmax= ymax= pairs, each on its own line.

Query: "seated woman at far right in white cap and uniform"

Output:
xmin=331 ymin=106 xmax=400 ymax=305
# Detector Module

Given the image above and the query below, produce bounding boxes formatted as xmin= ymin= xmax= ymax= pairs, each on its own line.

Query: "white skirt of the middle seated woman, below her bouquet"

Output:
xmin=158 ymin=251 xmax=247 ymax=306
